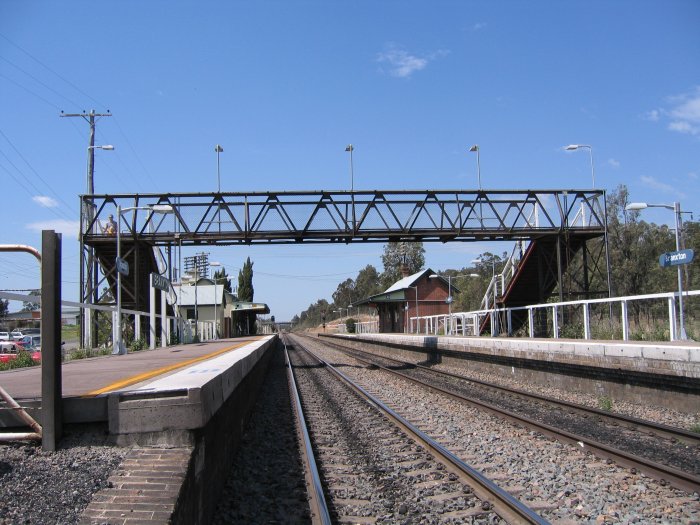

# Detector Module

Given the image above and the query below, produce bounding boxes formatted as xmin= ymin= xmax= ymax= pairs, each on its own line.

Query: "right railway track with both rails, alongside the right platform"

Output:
xmin=304 ymin=334 xmax=700 ymax=493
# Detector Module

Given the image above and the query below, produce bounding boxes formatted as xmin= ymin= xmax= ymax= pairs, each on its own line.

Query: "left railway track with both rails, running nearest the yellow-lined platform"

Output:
xmin=284 ymin=337 xmax=547 ymax=523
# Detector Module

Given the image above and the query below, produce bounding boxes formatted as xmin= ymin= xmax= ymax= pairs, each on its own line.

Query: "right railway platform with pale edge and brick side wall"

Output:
xmin=319 ymin=334 xmax=700 ymax=413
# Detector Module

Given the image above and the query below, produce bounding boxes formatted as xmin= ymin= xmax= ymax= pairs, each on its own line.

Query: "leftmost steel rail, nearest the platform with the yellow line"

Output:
xmin=284 ymin=344 xmax=332 ymax=525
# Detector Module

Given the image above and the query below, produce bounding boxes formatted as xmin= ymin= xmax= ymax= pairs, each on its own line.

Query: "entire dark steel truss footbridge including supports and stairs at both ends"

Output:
xmin=80 ymin=190 xmax=609 ymax=340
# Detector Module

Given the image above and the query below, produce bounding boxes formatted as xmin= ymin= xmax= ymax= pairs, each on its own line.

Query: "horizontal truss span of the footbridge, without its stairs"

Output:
xmin=80 ymin=190 xmax=606 ymax=245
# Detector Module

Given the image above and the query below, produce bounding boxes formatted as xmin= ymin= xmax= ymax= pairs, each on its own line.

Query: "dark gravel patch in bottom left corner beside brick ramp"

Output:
xmin=0 ymin=428 xmax=128 ymax=525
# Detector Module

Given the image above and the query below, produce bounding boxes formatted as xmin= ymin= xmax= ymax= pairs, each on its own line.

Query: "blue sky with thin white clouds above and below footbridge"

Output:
xmin=0 ymin=0 xmax=700 ymax=320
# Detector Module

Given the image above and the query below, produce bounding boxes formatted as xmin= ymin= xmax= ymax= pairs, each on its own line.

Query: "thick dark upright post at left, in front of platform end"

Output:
xmin=41 ymin=230 xmax=63 ymax=451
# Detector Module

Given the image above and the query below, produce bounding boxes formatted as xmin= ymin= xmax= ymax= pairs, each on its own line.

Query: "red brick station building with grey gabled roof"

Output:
xmin=353 ymin=268 xmax=458 ymax=333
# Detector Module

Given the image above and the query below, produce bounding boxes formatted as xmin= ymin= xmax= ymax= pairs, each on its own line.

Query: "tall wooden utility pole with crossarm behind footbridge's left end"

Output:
xmin=61 ymin=109 xmax=112 ymax=350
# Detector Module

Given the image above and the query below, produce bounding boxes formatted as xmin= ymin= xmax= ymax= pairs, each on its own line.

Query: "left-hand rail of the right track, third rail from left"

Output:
xmin=318 ymin=338 xmax=700 ymax=493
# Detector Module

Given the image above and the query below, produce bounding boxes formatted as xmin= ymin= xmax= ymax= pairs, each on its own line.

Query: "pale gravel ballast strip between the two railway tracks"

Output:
xmin=298 ymin=341 xmax=700 ymax=523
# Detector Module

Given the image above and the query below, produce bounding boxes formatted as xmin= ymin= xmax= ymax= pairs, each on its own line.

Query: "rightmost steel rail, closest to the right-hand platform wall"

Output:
xmin=329 ymin=342 xmax=700 ymax=447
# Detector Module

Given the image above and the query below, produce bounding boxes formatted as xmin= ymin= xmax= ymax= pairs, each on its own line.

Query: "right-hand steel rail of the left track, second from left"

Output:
xmin=292 ymin=336 xmax=549 ymax=525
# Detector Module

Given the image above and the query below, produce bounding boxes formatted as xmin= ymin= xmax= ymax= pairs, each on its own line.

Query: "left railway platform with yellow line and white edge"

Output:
xmin=0 ymin=336 xmax=276 ymax=445
